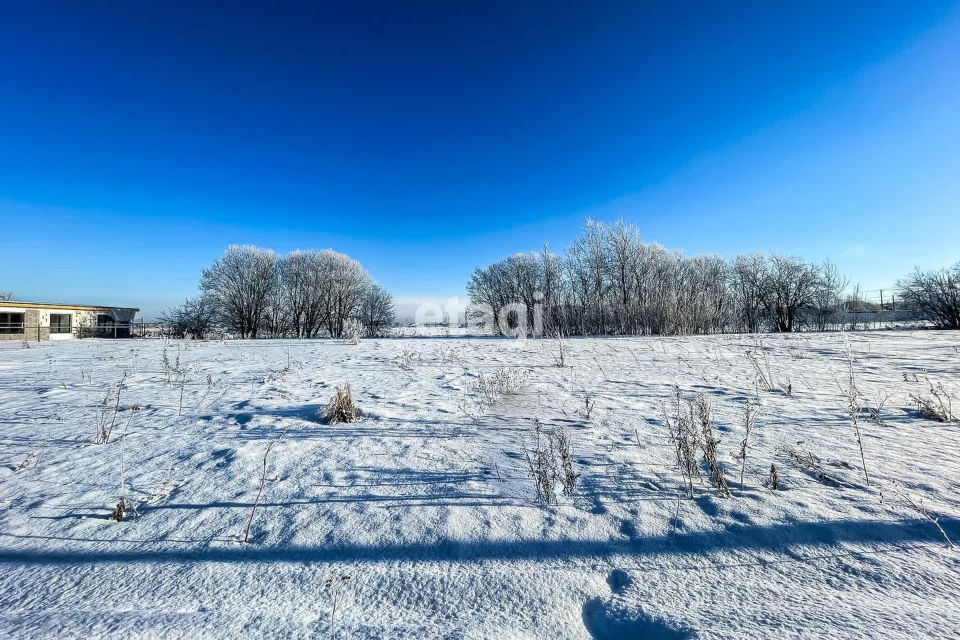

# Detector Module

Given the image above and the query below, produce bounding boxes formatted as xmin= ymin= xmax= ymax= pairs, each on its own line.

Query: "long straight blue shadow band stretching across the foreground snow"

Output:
xmin=0 ymin=516 xmax=960 ymax=566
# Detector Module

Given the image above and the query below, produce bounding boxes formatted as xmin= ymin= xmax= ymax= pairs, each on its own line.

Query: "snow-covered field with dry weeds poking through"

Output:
xmin=0 ymin=331 xmax=960 ymax=639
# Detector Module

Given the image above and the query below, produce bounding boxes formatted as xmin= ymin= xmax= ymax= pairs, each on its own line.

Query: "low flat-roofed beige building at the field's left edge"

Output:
xmin=0 ymin=300 xmax=139 ymax=341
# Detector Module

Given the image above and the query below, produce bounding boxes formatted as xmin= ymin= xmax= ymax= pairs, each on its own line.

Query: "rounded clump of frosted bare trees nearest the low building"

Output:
xmin=161 ymin=245 xmax=396 ymax=338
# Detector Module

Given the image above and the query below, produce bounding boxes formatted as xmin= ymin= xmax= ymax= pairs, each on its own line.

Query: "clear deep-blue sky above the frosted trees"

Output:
xmin=0 ymin=0 xmax=960 ymax=318
